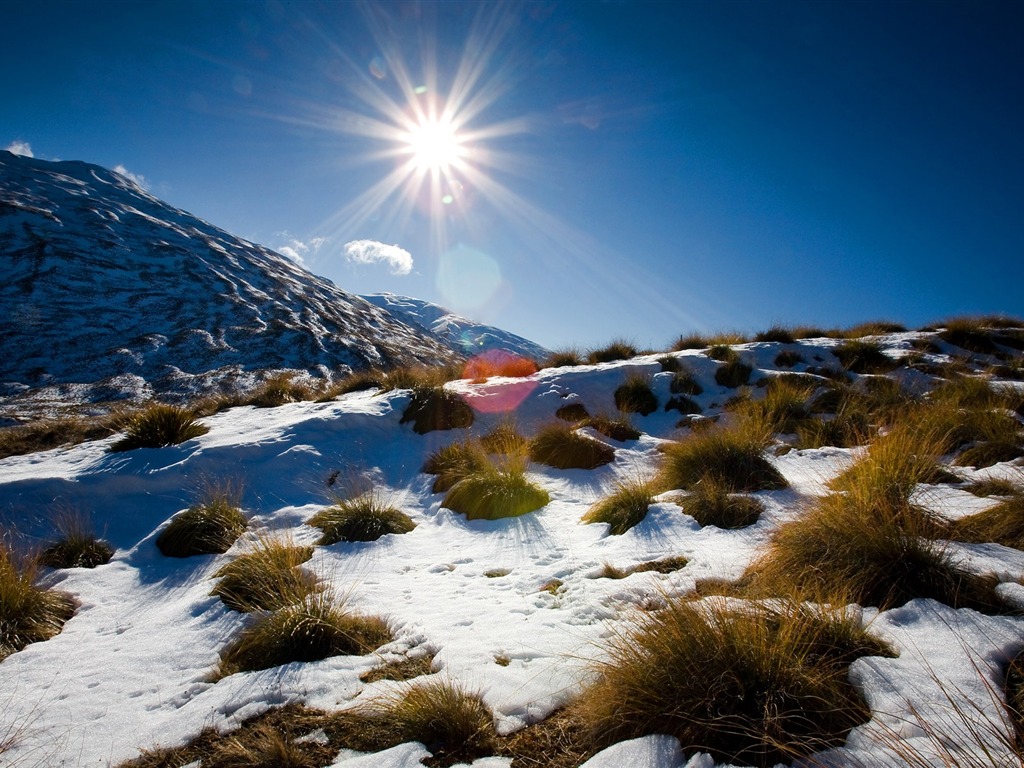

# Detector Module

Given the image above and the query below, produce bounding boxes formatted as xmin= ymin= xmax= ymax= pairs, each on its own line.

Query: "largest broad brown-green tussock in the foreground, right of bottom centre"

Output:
xmin=574 ymin=600 xmax=892 ymax=766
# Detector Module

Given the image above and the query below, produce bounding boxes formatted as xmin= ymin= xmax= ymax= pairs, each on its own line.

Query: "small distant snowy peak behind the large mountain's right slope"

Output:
xmin=362 ymin=293 xmax=549 ymax=360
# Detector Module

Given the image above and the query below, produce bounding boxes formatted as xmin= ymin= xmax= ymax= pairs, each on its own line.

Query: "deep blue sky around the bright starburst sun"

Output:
xmin=0 ymin=0 xmax=1024 ymax=347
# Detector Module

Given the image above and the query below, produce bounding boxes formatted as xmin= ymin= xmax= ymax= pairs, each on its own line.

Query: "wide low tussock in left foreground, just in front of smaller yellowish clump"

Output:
xmin=217 ymin=592 xmax=392 ymax=677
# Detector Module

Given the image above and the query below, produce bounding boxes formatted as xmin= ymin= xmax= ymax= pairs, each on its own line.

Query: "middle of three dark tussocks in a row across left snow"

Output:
xmin=157 ymin=483 xmax=249 ymax=557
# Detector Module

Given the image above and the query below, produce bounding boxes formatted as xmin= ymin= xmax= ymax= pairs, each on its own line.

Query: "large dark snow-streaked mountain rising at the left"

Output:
xmin=0 ymin=152 xmax=455 ymax=415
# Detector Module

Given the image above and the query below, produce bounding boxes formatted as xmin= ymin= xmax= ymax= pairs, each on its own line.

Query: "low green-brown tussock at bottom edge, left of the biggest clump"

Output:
xmin=336 ymin=679 xmax=498 ymax=766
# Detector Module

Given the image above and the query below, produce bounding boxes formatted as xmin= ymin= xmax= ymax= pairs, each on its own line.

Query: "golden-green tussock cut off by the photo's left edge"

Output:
xmin=0 ymin=544 xmax=75 ymax=662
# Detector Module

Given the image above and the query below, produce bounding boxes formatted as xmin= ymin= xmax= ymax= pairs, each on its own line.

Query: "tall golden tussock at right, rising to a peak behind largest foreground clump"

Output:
xmin=745 ymin=427 xmax=1000 ymax=612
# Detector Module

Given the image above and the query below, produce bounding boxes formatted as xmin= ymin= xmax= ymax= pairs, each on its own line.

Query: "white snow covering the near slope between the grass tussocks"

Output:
xmin=0 ymin=345 xmax=1024 ymax=768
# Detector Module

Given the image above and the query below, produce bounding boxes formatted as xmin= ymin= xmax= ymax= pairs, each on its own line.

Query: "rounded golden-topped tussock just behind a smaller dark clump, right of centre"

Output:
xmin=657 ymin=425 xmax=787 ymax=493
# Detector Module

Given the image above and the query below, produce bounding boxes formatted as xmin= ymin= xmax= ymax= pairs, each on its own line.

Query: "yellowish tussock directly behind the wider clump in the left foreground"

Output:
xmin=210 ymin=536 xmax=316 ymax=612
